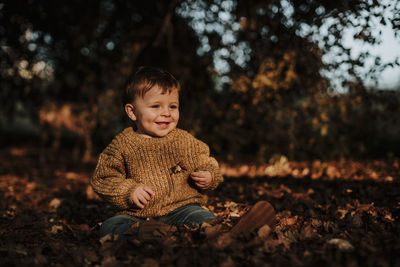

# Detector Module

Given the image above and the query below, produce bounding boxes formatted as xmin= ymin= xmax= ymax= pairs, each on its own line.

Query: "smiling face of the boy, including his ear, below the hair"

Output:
xmin=125 ymin=86 xmax=179 ymax=137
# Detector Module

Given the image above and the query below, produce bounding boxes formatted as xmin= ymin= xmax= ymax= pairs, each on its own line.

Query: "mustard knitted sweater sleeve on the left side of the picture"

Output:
xmin=90 ymin=140 xmax=139 ymax=209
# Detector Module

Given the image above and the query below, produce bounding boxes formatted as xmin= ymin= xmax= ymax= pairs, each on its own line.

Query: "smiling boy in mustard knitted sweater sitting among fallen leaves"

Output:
xmin=90 ymin=67 xmax=276 ymax=239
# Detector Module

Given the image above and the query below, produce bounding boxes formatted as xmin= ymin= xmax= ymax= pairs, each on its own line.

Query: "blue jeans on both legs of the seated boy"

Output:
xmin=99 ymin=203 xmax=216 ymax=239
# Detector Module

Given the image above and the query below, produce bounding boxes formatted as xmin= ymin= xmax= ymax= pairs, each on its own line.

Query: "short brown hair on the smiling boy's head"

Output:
xmin=122 ymin=67 xmax=180 ymax=105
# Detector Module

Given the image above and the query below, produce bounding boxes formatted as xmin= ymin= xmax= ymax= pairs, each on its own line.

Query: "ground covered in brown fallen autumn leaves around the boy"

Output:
xmin=0 ymin=147 xmax=400 ymax=266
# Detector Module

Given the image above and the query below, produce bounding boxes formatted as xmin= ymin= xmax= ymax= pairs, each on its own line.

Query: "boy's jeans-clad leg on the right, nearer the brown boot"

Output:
xmin=155 ymin=203 xmax=216 ymax=226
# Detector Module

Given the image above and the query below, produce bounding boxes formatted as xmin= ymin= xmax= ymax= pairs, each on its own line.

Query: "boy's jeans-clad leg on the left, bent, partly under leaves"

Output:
xmin=99 ymin=215 xmax=143 ymax=240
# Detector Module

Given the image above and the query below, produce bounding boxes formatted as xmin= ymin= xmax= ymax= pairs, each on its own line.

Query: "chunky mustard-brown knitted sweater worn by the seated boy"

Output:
xmin=90 ymin=127 xmax=223 ymax=217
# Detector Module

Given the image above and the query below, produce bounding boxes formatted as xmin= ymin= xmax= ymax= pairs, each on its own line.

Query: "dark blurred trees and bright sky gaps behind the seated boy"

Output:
xmin=0 ymin=0 xmax=400 ymax=163
